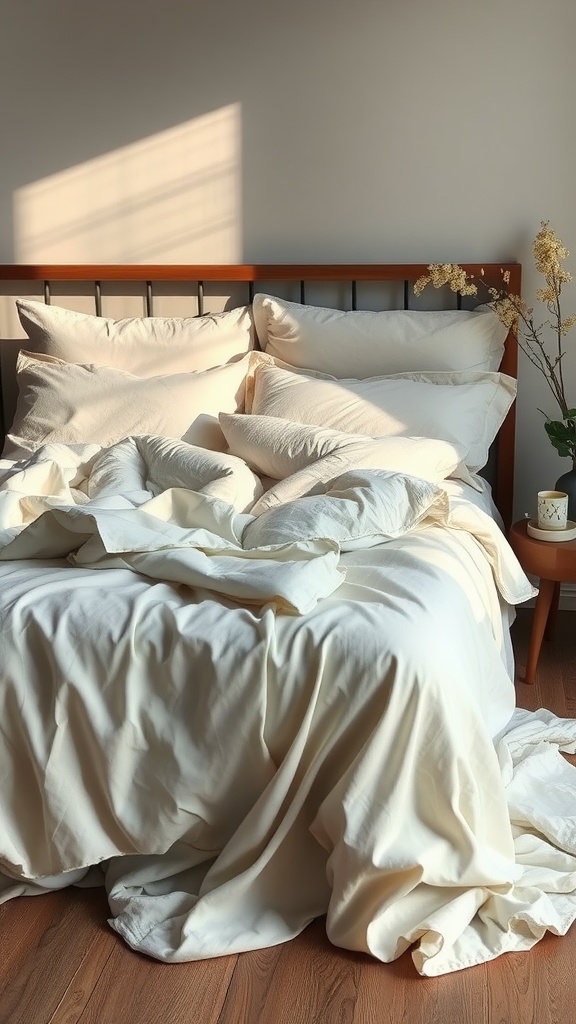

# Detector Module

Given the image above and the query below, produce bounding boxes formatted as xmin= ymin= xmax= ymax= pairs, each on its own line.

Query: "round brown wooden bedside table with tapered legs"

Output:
xmin=508 ymin=519 xmax=576 ymax=683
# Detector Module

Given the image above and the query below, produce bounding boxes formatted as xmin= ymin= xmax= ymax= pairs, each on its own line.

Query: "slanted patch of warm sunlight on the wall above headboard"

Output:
xmin=14 ymin=103 xmax=242 ymax=263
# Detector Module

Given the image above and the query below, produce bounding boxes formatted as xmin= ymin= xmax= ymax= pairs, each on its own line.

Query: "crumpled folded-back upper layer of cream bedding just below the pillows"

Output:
xmin=0 ymin=436 xmax=533 ymax=613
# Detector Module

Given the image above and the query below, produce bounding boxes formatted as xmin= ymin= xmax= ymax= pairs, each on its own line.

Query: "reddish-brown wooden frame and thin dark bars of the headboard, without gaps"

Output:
xmin=0 ymin=263 xmax=522 ymax=526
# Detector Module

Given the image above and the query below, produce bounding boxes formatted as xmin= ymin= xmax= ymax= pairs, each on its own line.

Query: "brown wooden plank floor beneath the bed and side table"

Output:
xmin=0 ymin=609 xmax=576 ymax=1024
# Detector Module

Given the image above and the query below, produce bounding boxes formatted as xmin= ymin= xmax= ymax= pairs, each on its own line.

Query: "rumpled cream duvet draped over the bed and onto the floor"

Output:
xmin=0 ymin=437 xmax=576 ymax=975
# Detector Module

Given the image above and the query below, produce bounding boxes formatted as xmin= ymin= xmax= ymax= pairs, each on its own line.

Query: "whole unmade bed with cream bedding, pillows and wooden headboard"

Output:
xmin=0 ymin=264 xmax=576 ymax=975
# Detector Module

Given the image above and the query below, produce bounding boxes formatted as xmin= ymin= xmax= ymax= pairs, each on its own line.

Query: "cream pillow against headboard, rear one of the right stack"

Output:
xmin=252 ymin=293 xmax=508 ymax=379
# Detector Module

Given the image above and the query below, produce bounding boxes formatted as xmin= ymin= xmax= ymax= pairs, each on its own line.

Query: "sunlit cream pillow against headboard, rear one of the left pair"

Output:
xmin=16 ymin=299 xmax=254 ymax=377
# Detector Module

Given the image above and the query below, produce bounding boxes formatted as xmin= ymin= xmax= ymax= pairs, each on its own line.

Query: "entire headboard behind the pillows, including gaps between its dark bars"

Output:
xmin=0 ymin=263 xmax=522 ymax=525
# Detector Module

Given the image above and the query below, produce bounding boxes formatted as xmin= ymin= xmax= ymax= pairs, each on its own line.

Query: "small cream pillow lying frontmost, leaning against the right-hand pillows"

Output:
xmin=219 ymin=413 xmax=464 ymax=485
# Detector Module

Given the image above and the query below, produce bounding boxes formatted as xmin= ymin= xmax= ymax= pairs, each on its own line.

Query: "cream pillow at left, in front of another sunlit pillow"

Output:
xmin=3 ymin=351 xmax=249 ymax=458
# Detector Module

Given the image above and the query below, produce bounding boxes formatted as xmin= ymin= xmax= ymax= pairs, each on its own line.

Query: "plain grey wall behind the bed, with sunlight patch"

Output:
xmin=0 ymin=0 xmax=576 ymax=514
